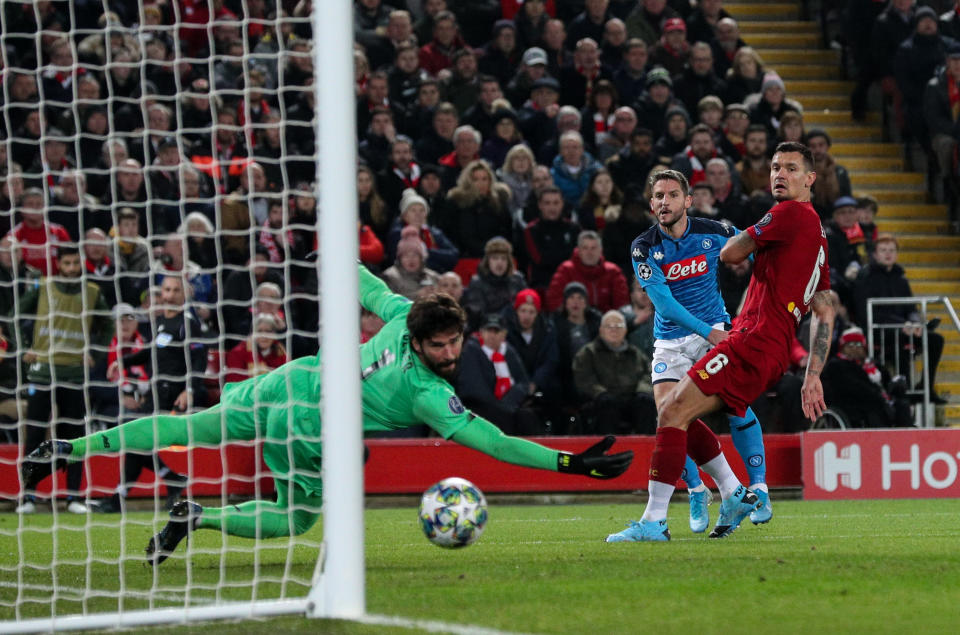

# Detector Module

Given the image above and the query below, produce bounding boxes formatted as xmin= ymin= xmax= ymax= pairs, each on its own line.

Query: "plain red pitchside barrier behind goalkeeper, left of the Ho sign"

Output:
xmin=0 ymin=434 xmax=801 ymax=499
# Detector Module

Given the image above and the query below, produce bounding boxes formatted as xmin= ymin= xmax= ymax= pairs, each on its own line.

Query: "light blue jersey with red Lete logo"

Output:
xmin=630 ymin=218 xmax=739 ymax=340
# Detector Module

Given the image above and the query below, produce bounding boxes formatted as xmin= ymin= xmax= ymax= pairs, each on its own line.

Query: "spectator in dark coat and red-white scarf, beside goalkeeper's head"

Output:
xmin=457 ymin=314 xmax=542 ymax=435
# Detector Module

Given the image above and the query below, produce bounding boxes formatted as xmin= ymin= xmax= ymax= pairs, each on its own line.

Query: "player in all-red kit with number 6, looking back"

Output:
xmin=607 ymin=142 xmax=836 ymax=542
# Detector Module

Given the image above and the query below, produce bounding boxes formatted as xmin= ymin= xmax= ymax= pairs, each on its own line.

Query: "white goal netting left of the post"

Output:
xmin=0 ymin=0 xmax=344 ymax=630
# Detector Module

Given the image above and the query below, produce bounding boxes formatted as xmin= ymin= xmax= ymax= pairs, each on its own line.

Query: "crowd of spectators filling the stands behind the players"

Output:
xmin=0 ymin=0 xmax=944 ymax=462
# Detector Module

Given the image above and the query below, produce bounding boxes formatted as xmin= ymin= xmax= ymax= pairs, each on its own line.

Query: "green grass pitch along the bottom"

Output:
xmin=0 ymin=499 xmax=960 ymax=635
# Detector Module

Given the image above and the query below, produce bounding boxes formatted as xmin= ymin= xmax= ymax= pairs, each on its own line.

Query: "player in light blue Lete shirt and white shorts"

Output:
xmin=630 ymin=170 xmax=773 ymax=533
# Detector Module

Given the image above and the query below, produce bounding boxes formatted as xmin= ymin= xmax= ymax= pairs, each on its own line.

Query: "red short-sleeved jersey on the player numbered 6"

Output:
xmin=734 ymin=201 xmax=830 ymax=355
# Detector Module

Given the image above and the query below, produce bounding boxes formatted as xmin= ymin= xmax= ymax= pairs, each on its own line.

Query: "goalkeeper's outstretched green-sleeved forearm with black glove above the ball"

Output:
xmin=451 ymin=415 xmax=633 ymax=479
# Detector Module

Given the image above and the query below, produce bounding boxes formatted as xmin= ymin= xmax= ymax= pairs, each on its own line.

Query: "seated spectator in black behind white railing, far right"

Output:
xmin=853 ymin=234 xmax=946 ymax=404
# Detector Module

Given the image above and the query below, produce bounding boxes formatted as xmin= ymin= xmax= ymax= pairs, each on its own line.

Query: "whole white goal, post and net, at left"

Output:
xmin=0 ymin=0 xmax=364 ymax=632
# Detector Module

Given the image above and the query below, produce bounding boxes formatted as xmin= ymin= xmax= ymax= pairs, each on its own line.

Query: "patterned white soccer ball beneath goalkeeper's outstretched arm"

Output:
xmin=420 ymin=476 xmax=487 ymax=549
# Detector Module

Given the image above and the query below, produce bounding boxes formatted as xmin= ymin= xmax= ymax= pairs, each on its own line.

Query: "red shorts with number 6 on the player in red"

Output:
xmin=687 ymin=331 xmax=787 ymax=417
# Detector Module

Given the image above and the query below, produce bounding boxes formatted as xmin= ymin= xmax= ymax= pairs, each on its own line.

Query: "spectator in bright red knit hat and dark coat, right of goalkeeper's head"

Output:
xmin=504 ymin=289 xmax=560 ymax=404
